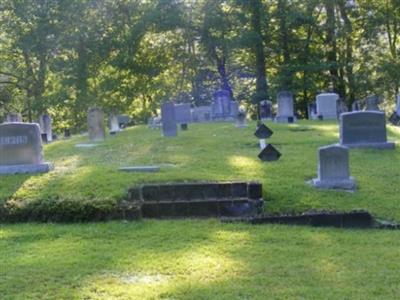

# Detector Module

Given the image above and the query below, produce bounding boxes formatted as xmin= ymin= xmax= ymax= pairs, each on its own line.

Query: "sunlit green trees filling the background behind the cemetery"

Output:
xmin=0 ymin=0 xmax=400 ymax=130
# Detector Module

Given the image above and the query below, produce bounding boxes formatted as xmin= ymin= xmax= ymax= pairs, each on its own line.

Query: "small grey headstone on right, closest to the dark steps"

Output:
xmin=312 ymin=145 xmax=356 ymax=190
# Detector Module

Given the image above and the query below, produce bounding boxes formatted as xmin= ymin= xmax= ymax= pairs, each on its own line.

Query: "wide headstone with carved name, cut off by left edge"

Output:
xmin=0 ymin=123 xmax=51 ymax=175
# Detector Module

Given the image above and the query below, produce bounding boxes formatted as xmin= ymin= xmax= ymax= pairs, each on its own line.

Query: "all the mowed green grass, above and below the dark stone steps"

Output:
xmin=0 ymin=121 xmax=400 ymax=299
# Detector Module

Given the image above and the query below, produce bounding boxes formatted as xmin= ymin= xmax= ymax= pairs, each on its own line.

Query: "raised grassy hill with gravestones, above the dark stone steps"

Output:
xmin=0 ymin=121 xmax=400 ymax=221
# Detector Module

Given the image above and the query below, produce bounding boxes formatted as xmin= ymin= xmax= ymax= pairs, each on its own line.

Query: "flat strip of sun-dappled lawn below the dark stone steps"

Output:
xmin=0 ymin=220 xmax=400 ymax=299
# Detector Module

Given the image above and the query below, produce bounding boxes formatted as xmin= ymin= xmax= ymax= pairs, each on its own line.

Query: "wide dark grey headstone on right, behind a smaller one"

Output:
xmin=340 ymin=111 xmax=395 ymax=149
